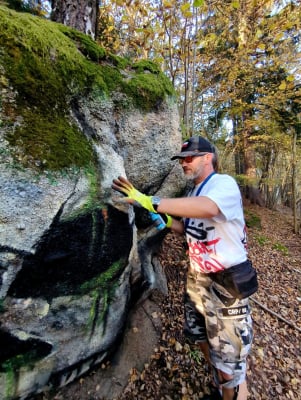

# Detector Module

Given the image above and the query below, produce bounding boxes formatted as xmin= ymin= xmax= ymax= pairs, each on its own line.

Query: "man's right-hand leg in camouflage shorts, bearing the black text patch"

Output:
xmin=204 ymin=287 xmax=253 ymax=400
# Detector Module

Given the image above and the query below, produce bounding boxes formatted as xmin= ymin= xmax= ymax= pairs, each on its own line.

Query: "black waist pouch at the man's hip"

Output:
xmin=209 ymin=260 xmax=258 ymax=299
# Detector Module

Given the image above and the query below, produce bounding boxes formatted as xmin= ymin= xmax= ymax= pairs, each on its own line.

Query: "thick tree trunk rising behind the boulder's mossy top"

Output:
xmin=51 ymin=0 xmax=99 ymax=39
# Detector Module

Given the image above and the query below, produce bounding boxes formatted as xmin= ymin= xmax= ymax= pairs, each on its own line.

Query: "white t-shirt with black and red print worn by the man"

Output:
xmin=184 ymin=174 xmax=247 ymax=273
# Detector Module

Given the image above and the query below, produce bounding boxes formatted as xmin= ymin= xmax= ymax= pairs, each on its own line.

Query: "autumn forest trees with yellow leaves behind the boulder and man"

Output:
xmin=5 ymin=0 xmax=301 ymax=233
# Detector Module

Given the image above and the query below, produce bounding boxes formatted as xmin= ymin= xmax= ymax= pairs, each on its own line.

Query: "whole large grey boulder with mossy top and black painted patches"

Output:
xmin=0 ymin=7 xmax=185 ymax=400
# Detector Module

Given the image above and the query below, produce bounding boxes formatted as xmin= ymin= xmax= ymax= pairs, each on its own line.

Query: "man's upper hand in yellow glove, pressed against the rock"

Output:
xmin=112 ymin=176 xmax=156 ymax=213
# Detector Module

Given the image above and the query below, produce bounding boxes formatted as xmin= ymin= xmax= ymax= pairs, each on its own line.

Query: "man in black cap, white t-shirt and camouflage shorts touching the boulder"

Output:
xmin=112 ymin=136 xmax=257 ymax=400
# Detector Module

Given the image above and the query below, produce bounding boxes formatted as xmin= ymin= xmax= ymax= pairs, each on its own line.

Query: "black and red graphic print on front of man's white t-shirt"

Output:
xmin=186 ymin=221 xmax=225 ymax=274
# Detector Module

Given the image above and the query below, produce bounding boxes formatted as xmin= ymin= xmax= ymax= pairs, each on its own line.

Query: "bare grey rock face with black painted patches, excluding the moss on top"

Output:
xmin=0 ymin=3 xmax=185 ymax=400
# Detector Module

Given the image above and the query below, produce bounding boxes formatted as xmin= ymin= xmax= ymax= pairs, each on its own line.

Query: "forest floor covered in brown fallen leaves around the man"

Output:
xmin=36 ymin=205 xmax=301 ymax=400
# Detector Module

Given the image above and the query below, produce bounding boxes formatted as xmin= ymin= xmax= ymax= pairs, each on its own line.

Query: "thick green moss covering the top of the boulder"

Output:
xmin=0 ymin=6 xmax=174 ymax=170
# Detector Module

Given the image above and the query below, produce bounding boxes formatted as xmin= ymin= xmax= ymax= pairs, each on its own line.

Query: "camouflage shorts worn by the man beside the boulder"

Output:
xmin=185 ymin=274 xmax=253 ymax=387
